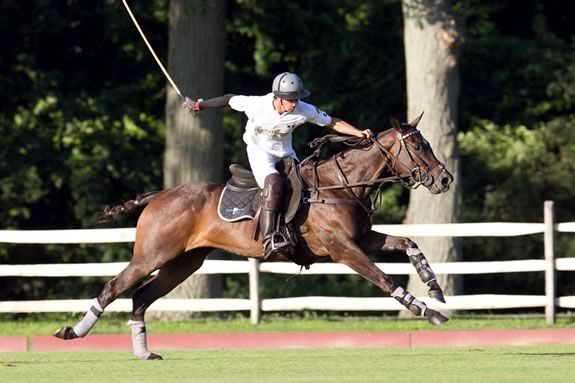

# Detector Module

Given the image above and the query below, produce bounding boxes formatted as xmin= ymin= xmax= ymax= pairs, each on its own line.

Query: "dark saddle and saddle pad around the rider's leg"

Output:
xmin=218 ymin=157 xmax=303 ymax=225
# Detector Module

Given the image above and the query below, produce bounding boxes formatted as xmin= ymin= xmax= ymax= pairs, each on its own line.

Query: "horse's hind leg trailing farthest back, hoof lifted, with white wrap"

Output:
xmin=53 ymin=259 xmax=153 ymax=340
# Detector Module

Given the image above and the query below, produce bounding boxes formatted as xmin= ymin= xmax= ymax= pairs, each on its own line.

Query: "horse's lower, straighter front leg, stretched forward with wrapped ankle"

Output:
xmin=327 ymin=232 xmax=449 ymax=326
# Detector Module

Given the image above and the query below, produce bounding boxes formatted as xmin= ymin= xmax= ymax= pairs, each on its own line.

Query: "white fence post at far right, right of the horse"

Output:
xmin=543 ymin=201 xmax=555 ymax=324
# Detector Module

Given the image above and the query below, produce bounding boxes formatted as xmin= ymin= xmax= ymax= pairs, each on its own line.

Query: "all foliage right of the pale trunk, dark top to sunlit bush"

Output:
xmin=459 ymin=0 xmax=575 ymax=294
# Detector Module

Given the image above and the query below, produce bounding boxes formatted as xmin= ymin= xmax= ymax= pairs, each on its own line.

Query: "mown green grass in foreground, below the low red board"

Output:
xmin=0 ymin=346 xmax=575 ymax=383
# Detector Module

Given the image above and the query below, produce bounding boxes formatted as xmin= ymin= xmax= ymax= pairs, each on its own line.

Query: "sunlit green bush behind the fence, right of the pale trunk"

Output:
xmin=459 ymin=117 xmax=575 ymax=293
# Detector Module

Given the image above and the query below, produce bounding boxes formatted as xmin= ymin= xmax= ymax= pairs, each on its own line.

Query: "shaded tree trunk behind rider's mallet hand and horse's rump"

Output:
xmin=161 ymin=0 xmax=226 ymax=320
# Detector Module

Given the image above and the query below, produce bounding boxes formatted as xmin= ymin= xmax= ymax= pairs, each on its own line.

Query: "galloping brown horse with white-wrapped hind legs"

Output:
xmin=53 ymin=113 xmax=453 ymax=360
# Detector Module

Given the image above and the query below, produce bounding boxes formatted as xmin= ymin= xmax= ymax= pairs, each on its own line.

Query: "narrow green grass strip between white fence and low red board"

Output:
xmin=0 ymin=314 xmax=575 ymax=336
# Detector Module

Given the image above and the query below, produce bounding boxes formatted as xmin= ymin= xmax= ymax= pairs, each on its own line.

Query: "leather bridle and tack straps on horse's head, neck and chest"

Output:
xmin=301 ymin=127 xmax=445 ymax=214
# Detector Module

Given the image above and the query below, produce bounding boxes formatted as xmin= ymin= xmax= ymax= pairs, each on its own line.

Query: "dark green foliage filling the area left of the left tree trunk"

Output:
xmin=0 ymin=0 xmax=166 ymax=300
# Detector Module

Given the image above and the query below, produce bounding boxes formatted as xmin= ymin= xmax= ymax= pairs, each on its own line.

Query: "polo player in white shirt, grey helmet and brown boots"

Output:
xmin=183 ymin=72 xmax=373 ymax=259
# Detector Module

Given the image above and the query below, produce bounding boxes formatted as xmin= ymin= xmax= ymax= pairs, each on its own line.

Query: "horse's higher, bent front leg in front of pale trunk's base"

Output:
xmin=361 ymin=230 xmax=445 ymax=303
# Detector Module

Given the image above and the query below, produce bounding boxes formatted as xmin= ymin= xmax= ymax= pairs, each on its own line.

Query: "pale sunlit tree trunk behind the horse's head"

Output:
xmin=403 ymin=0 xmax=462 ymax=304
